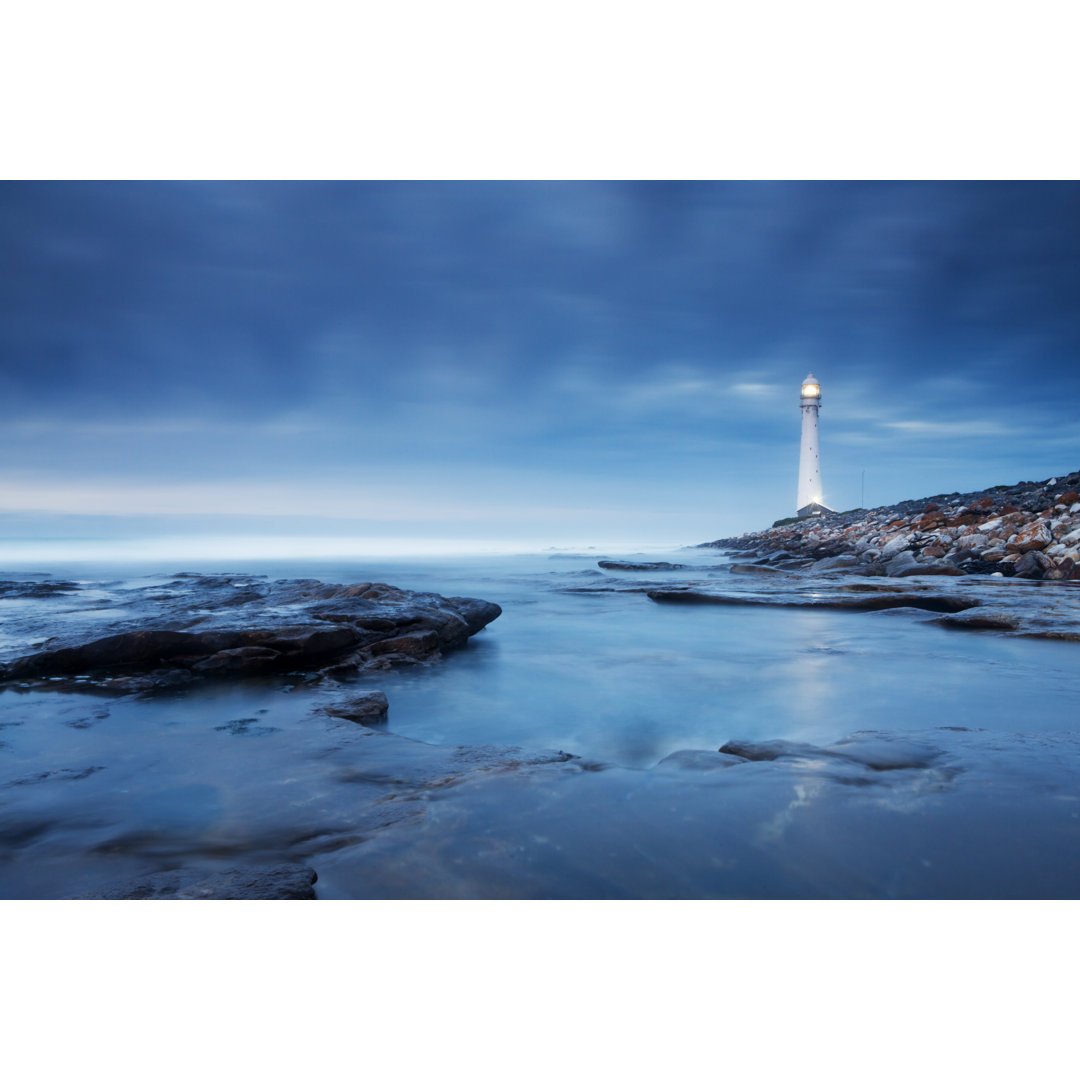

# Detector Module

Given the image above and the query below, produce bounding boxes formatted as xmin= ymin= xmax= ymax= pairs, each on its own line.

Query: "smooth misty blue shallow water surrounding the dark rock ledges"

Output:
xmin=0 ymin=552 xmax=1080 ymax=896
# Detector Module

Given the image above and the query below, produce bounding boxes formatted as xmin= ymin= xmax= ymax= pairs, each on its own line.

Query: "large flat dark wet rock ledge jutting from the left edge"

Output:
xmin=0 ymin=573 xmax=501 ymax=692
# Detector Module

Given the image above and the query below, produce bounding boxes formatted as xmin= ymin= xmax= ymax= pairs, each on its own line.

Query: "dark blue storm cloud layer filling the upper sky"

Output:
xmin=6 ymin=184 xmax=1080 ymax=423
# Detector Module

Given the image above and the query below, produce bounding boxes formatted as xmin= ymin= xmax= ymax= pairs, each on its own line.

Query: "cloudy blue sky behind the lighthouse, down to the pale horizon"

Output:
xmin=0 ymin=181 xmax=1080 ymax=550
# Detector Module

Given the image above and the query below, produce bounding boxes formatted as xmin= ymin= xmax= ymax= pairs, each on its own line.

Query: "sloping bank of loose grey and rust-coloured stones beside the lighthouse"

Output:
xmin=698 ymin=472 xmax=1080 ymax=581
